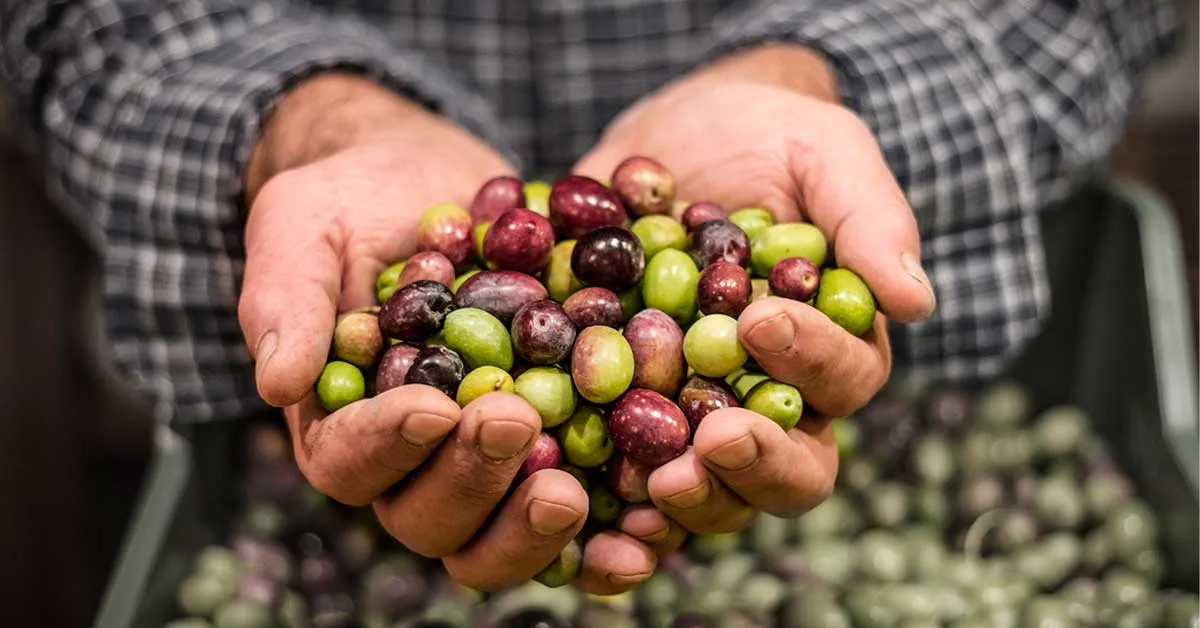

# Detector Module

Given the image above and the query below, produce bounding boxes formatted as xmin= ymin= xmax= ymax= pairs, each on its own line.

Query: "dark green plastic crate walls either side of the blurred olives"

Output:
xmin=95 ymin=181 xmax=1200 ymax=628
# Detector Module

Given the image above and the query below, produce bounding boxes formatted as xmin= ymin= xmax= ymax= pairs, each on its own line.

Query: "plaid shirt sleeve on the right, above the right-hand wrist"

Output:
xmin=712 ymin=0 xmax=1177 ymax=378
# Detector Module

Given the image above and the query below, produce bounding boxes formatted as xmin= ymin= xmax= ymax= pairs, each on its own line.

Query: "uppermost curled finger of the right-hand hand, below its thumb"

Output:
xmin=738 ymin=297 xmax=892 ymax=417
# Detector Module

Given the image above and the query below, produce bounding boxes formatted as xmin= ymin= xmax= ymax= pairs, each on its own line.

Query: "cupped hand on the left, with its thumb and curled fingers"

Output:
xmin=239 ymin=74 xmax=679 ymax=592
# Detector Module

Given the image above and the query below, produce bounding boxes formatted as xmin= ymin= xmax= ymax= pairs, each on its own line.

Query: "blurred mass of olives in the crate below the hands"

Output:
xmin=169 ymin=384 xmax=1200 ymax=628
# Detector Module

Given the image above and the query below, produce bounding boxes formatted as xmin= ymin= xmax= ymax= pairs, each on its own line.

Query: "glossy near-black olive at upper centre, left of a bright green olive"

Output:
xmin=571 ymin=227 xmax=646 ymax=292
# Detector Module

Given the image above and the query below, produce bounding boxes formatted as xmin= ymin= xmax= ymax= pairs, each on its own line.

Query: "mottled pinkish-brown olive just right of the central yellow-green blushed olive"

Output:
xmin=624 ymin=309 xmax=688 ymax=399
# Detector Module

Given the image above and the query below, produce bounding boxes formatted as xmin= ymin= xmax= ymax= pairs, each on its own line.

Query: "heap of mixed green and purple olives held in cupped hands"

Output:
xmin=316 ymin=157 xmax=876 ymax=573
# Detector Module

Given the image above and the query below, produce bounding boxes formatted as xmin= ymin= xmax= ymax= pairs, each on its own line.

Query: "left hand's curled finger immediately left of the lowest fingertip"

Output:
xmin=444 ymin=469 xmax=588 ymax=591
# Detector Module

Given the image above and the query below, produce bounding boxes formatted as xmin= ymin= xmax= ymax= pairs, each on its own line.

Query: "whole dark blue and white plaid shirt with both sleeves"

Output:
xmin=0 ymin=0 xmax=1175 ymax=420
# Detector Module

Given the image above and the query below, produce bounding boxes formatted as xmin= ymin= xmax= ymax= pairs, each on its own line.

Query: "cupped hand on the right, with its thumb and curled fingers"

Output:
xmin=576 ymin=44 xmax=935 ymax=532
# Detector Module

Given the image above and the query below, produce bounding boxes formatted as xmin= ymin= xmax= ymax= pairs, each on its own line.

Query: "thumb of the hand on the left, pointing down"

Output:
xmin=238 ymin=174 xmax=343 ymax=407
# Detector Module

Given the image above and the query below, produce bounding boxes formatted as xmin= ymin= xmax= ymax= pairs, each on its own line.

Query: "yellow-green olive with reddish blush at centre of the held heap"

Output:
xmin=571 ymin=325 xmax=634 ymax=403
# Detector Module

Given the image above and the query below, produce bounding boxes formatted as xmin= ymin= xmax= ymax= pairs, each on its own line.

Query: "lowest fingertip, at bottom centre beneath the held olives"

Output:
xmin=578 ymin=530 xmax=658 ymax=596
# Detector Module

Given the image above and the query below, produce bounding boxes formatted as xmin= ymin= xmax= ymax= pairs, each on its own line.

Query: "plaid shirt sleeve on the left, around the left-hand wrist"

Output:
xmin=0 ymin=0 xmax=511 ymax=420
